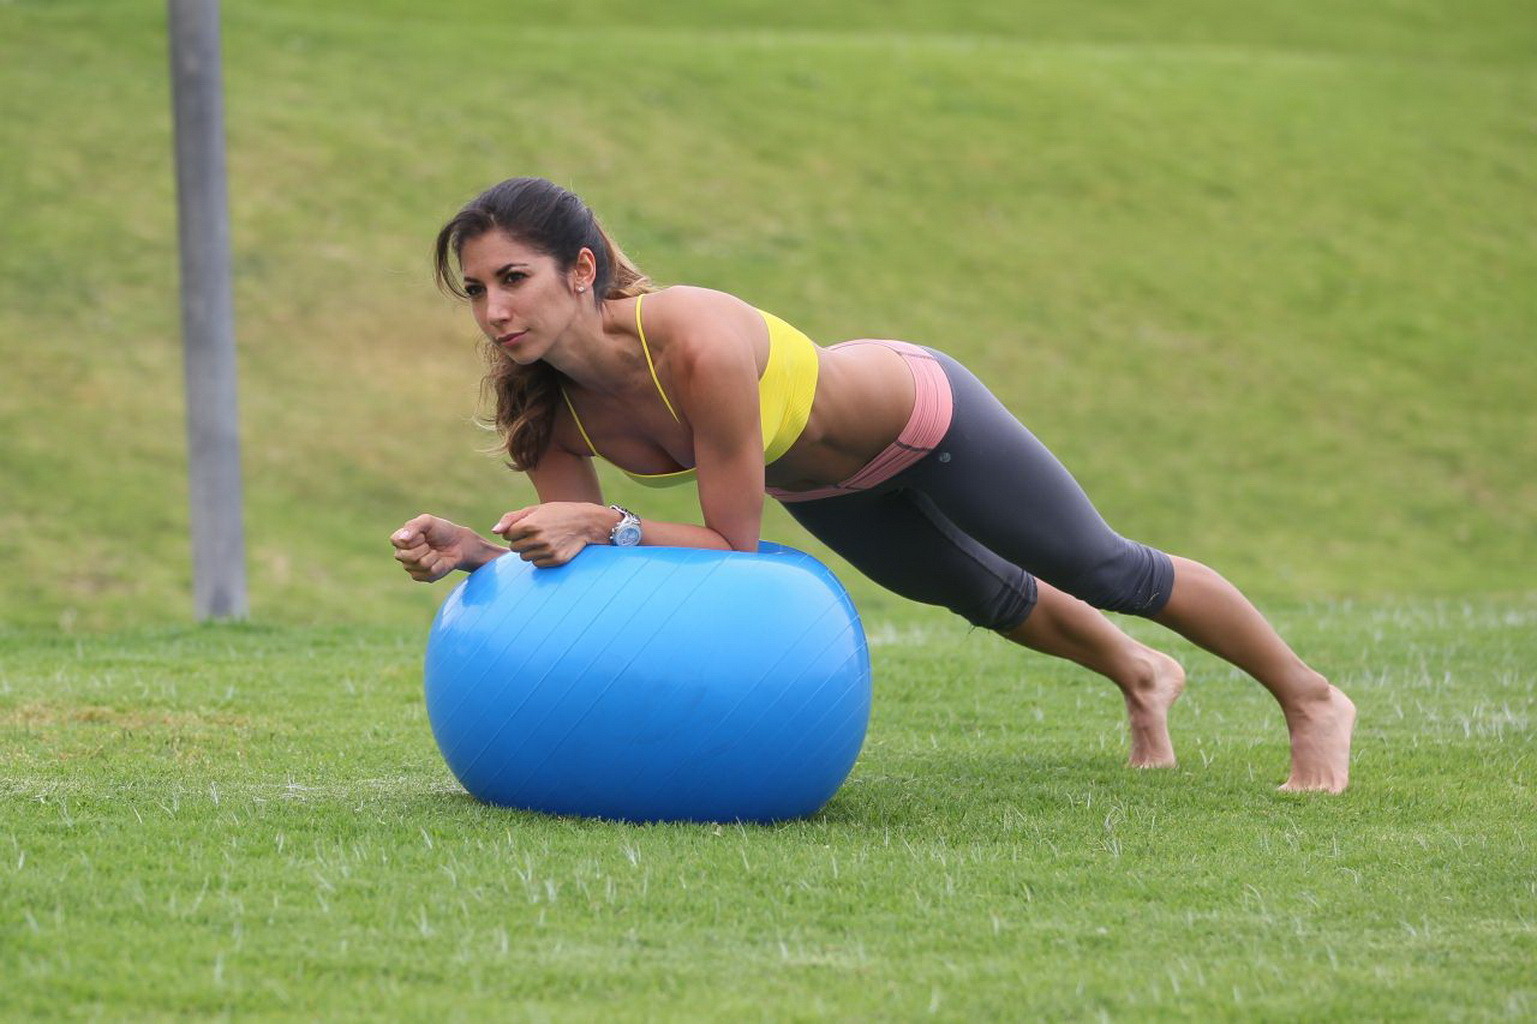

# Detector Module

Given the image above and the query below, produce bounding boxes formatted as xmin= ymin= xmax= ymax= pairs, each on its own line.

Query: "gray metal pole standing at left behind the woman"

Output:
xmin=168 ymin=0 xmax=247 ymax=620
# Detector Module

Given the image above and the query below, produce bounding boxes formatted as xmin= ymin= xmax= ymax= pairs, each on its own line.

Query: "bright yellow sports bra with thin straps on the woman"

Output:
xmin=561 ymin=295 xmax=816 ymax=487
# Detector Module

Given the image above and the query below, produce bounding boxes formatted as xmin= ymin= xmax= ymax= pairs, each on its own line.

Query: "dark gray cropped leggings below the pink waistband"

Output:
xmin=784 ymin=349 xmax=1174 ymax=632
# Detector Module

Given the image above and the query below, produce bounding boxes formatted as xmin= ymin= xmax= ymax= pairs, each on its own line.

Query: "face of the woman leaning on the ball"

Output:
xmin=460 ymin=231 xmax=592 ymax=364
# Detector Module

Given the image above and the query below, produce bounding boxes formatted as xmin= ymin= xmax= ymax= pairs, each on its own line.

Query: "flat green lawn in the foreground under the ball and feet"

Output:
xmin=0 ymin=601 xmax=1537 ymax=1021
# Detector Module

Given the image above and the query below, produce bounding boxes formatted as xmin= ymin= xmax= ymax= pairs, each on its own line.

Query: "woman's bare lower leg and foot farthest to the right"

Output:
xmin=1153 ymin=558 xmax=1356 ymax=793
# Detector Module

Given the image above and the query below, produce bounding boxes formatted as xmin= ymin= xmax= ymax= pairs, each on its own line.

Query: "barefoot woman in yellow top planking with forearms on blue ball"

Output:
xmin=392 ymin=178 xmax=1356 ymax=792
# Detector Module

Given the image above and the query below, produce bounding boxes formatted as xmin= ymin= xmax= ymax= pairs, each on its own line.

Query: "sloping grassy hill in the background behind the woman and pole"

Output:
xmin=0 ymin=0 xmax=1537 ymax=629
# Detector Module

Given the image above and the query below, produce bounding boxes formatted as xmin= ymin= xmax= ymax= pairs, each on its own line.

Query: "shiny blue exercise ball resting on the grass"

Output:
xmin=426 ymin=544 xmax=870 ymax=821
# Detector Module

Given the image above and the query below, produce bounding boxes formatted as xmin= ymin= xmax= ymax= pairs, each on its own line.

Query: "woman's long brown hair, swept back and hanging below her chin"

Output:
xmin=433 ymin=178 xmax=653 ymax=470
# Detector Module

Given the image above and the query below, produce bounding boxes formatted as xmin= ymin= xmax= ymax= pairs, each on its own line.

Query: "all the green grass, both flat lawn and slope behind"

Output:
xmin=0 ymin=0 xmax=1537 ymax=1021
